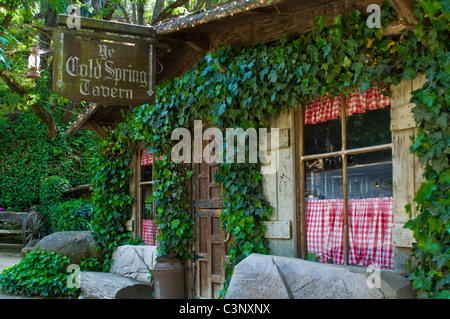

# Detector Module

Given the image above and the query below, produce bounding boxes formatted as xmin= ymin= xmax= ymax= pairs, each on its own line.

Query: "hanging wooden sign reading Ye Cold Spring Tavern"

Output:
xmin=53 ymin=15 xmax=155 ymax=107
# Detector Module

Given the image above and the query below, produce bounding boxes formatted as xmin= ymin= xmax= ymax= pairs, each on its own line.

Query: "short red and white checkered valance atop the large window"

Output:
xmin=304 ymin=88 xmax=391 ymax=124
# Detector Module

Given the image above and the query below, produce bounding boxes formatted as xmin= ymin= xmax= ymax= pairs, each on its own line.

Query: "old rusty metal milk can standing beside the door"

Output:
xmin=153 ymin=253 xmax=184 ymax=299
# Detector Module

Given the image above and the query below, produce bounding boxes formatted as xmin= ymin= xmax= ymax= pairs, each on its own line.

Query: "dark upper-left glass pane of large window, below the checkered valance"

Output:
xmin=304 ymin=119 xmax=342 ymax=155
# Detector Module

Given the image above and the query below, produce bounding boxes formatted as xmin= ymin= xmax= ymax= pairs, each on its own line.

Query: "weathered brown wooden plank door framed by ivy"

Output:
xmin=193 ymin=127 xmax=227 ymax=299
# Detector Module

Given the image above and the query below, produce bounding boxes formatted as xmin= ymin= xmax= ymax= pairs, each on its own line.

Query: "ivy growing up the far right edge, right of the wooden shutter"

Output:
xmin=405 ymin=0 xmax=450 ymax=298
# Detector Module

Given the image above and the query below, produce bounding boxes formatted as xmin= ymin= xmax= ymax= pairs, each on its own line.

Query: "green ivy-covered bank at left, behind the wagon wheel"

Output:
xmin=0 ymin=111 xmax=98 ymax=211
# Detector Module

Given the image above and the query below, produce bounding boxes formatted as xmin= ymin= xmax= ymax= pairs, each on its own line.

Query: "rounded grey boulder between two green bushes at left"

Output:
xmin=33 ymin=231 xmax=102 ymax=264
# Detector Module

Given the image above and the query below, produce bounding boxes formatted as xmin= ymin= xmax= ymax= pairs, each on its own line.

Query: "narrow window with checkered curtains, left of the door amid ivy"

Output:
xmin=137 ymin=149 xmax=158 ymax=246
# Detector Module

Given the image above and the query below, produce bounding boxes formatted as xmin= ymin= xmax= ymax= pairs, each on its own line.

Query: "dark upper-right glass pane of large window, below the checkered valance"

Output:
xmin=347 ymin=106 xmax=392 ymax=149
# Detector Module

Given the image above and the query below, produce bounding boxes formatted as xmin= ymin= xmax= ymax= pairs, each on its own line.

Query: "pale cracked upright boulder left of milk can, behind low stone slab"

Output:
xmin=110 ymin=245 xmax=157 ymax=283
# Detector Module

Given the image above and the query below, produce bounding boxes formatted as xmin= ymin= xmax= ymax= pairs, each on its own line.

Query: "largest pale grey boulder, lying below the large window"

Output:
xmin=225 ymin=254 xmax=415 ymax=299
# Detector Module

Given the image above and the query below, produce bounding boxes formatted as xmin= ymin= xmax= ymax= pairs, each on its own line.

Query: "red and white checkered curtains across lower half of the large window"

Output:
xmin=306 ymin=197 xmax=394 ymax=269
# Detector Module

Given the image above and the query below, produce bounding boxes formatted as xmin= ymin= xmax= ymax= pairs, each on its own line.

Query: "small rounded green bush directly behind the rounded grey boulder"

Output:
xmin=47 ymin=199 xmax=92 ymax=233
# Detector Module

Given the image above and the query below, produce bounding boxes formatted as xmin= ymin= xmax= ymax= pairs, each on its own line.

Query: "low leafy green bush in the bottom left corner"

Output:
xmin=0 ymin=250 xmax=78 ymax=297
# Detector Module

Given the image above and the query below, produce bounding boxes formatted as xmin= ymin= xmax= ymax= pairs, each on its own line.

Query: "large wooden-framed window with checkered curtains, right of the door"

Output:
xmin=299 ymin=90 xmax=393 ymax=268
